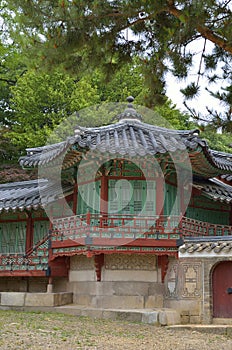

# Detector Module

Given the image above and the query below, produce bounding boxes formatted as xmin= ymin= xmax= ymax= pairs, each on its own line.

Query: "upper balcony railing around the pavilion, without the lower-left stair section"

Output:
xmin=52 ymin=213 xmax=232 ymax=241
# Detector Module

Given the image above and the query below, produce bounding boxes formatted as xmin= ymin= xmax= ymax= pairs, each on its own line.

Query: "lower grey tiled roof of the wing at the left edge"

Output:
xmin=0 ymin=179 xmax=72 ymax=213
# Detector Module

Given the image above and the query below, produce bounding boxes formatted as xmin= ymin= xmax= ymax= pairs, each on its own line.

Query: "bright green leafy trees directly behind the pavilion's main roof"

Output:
xmin=9 ymin=60 xmax=191 ymax=148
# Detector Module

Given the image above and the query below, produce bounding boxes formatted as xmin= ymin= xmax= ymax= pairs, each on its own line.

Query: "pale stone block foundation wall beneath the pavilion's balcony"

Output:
xmin=67 ymin=254 xmax=164 ymax=309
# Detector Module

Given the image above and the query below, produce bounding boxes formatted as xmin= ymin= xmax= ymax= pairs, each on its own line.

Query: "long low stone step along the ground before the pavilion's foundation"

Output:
xmin=54 ymin=304 xmax=180 ymax=326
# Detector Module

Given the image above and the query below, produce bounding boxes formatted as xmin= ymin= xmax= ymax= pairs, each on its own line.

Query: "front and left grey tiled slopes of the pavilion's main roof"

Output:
xmin=20 ymin=120 xmax=199 ymax=166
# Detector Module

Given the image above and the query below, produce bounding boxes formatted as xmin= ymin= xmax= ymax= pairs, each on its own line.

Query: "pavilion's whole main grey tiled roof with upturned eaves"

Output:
xmin=20 ymin=118 xmax=232 ymax=177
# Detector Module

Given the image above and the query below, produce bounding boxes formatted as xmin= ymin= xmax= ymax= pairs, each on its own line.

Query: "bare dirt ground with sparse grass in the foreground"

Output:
xmin=0 ymin=310 xmax=232 ymax=350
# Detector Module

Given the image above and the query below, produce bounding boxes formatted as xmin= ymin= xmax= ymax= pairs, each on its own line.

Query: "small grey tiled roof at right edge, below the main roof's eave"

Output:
xmin=193 ymin=178 xmax=232 ymax=203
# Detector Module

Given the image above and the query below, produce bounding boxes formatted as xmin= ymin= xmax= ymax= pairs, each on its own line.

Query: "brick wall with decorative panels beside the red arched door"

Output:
xmin=164 ymin=257 xmax=232 ymax=324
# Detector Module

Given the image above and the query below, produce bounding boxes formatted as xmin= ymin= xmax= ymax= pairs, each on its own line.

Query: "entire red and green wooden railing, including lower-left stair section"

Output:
xmin=0 ymin=213 xmax=232 ymax=274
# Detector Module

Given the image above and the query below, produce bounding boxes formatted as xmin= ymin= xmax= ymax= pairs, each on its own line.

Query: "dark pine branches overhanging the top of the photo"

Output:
xmin=3 ymin=0 xmax=232 ymax=120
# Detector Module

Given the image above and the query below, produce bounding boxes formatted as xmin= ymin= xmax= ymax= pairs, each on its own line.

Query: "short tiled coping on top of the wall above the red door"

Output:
xmin=179 ymin=236 xmax=232 ymax=255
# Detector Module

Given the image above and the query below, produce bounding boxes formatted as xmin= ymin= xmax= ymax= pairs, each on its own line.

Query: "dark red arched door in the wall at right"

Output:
xmin=212 ymin=261 xmax=232 ymax=318
